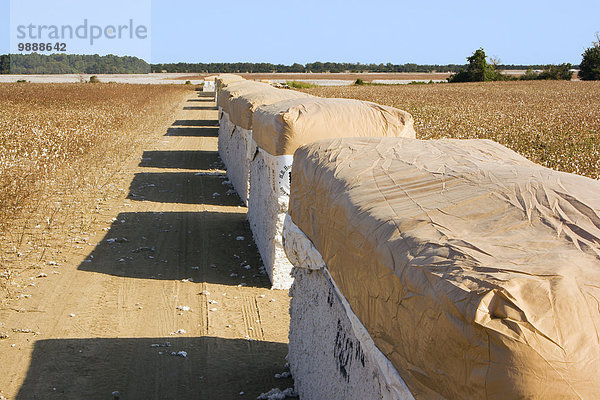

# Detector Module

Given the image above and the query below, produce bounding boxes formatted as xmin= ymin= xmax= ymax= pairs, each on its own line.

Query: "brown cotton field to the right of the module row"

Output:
xmin=303 ymin=81 xmax=600 ymax=179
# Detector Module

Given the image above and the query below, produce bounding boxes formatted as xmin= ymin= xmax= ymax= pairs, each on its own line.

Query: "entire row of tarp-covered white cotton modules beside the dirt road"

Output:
xmin=216 ymin=75 xmax=600 ymax=400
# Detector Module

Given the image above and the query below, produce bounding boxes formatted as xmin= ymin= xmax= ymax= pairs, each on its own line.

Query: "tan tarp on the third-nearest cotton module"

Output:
xmin=229 ymin=85 xmax=313 ymax=130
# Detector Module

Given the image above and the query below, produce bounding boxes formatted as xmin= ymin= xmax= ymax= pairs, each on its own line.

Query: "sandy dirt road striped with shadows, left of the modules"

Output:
xmin=0 ymin=92 xmax=293 ymax=400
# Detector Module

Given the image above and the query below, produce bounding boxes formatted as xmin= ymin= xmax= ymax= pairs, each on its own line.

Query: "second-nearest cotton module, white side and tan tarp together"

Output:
xmin=248 ymin=97 xmax=415 ymax=289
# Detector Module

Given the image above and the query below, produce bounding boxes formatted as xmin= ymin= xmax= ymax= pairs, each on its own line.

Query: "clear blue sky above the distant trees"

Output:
xmin=0 ymin=0 xmax=600 ymax=64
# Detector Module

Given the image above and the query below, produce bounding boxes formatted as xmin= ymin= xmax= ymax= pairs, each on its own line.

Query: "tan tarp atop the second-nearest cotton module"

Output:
xmin=252 ymin=97 xmax=415 ymax=156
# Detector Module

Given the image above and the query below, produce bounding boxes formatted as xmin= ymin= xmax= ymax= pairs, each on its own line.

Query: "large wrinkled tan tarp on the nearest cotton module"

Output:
xmin=289 ymin=138 xmax=600 ymax=399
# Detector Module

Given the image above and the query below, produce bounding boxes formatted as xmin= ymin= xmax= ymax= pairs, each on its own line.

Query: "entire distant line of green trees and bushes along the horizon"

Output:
xmin=0 ymin=52 xmax=600 ymax=78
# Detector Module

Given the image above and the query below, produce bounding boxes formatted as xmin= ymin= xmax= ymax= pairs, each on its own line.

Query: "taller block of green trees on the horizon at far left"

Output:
xmin=0 ymin=53 xmax=150 ymax=74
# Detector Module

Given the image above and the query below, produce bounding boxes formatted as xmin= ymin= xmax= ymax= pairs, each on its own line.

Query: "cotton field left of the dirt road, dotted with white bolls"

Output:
xmin=0 ymin=83 xmax=189 ymax=230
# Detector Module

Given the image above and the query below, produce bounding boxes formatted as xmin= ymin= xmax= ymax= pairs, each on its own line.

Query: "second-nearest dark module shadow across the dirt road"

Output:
xmin=79 ymin=211 xmax=270 ymax=288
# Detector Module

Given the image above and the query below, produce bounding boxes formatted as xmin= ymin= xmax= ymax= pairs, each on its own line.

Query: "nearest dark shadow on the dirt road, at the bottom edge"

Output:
xmin=16 ymin=337 xmax=292 ymax=400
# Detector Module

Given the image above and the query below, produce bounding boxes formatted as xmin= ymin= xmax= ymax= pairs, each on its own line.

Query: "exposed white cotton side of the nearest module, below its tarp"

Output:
xmin=284 ymin=216 xmax=413 ymax=400
